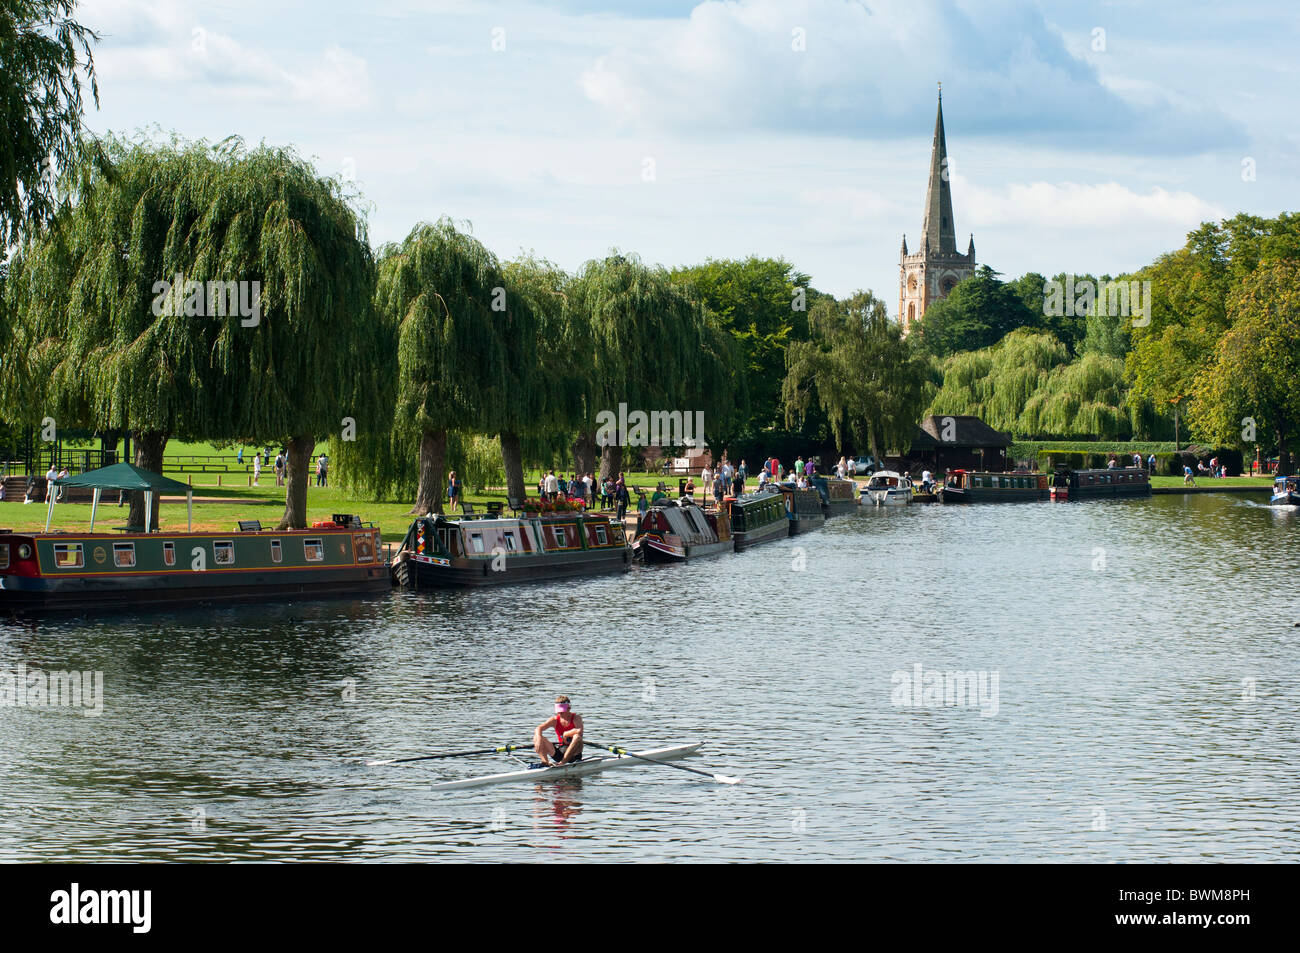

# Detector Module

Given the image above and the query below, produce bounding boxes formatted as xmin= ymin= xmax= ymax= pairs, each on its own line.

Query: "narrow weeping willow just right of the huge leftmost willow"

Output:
xmin=374 ymin=218 xmax=511 ymax=515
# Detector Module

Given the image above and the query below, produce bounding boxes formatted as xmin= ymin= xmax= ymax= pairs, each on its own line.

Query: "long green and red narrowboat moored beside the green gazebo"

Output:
xmin=0 ymin=515 xmax=391 ymax=611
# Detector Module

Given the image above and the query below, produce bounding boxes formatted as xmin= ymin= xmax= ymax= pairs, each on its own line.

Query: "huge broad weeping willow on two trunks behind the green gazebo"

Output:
xmin=5 ymin=140 xmax=378 ymax=528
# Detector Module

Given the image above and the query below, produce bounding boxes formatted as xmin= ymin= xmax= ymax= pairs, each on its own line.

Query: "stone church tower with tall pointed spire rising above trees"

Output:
xmin=898 ymin=86 xmax=975 ymax=334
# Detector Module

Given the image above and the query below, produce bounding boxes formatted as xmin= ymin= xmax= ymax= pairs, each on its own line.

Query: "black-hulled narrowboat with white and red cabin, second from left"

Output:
xmin=393 ymin=510 xmax=632 ymax=589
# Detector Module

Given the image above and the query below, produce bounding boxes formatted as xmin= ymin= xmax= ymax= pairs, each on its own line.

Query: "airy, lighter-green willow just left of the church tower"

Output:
xmin=781 ymin=291 xmax=926 ymax=460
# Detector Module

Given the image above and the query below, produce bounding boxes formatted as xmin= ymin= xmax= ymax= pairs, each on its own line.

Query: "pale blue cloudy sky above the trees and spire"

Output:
xmin=77 ymin=0 xmax=1300 ymax=304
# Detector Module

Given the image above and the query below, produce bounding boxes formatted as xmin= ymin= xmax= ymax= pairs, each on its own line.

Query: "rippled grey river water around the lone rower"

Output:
xmin=0 ymin=495 xmax=1300 ymax=861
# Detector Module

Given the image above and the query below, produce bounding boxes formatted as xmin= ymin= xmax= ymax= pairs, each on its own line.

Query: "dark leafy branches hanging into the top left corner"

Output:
xmin=0 ymin=0 xmax=99 ymax=244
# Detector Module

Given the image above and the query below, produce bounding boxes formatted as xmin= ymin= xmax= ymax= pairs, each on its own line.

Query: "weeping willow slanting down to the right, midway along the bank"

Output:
xmin=569 ymin=251 xmax=744 ymax=480
